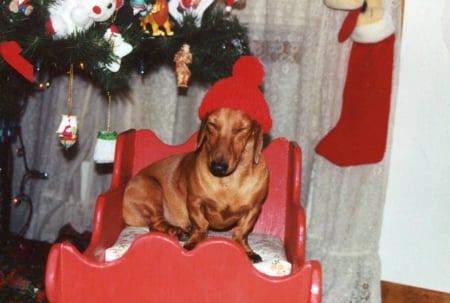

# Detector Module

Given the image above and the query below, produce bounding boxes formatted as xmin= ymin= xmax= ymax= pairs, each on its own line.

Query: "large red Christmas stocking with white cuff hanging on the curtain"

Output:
xmin=316 ymin=12 xmax=395 ymax=166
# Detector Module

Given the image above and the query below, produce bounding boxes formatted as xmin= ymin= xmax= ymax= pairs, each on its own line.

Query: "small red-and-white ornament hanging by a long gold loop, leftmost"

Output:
xmin=56 ymin=64 xmax=78 ymax=149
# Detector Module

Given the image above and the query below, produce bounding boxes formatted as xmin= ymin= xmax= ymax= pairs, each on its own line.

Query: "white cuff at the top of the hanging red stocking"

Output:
xmin=350 ymin=16 xmax=395 ymax=43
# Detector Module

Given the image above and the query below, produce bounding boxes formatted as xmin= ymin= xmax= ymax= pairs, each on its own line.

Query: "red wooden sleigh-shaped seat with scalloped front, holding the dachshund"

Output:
xmin=45 ymin=130 xmax=322 ymax=303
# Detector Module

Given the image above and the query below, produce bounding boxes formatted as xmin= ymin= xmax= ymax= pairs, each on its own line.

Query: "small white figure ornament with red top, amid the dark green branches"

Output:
xmin=103 ymin=25 xmax=133 ymax=72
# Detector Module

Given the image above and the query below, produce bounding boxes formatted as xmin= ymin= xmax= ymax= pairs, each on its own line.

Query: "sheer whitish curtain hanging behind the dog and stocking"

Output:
xmin=12 ymin=0 xmax=402 ymax=303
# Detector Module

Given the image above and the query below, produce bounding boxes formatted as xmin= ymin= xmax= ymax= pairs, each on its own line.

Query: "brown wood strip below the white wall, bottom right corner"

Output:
xmin=381 ymin=281 xmax=450 ymax=303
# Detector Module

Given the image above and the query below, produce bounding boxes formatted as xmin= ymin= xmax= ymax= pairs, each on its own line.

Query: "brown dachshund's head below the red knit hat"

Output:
xmin=197 ymin=108 xmax=263 ymax=177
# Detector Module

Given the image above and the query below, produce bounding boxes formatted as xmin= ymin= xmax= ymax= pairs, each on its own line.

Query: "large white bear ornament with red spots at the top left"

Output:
xmin=46 ymin=0 xmax=123 ymax=39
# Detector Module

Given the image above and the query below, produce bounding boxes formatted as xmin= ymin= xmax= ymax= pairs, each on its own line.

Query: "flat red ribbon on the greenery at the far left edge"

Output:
xmin=0 ymin=41 xmax=34 ymax=82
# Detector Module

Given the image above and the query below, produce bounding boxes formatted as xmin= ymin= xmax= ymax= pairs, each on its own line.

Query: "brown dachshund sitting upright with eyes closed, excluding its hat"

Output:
xmin=123 ymin=108 xmax=269 ymax=262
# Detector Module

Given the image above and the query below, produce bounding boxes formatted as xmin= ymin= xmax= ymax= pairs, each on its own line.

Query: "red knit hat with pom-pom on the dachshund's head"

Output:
xmin=198 ymin=56 xmax=272 ymax=133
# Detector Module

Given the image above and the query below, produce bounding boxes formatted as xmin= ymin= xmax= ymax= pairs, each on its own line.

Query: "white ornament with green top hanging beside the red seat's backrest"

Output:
xmin=93 ymin=92 xmax=117 ymax=164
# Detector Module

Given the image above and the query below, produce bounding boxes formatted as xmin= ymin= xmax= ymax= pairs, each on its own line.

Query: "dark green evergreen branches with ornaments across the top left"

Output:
xmin=0 ymin=0 xmax=249 ymax=129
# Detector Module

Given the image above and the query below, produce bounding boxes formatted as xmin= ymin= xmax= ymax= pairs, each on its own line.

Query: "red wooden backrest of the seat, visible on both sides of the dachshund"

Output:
xmin=111 ymin=129 xmax=301 ymax=240
